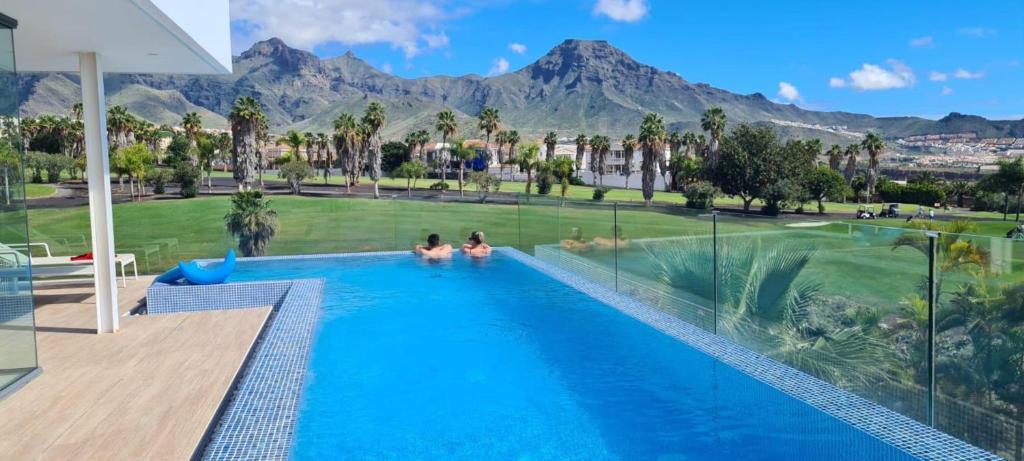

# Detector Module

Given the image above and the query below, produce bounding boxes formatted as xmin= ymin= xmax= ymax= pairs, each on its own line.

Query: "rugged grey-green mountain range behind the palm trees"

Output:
xmin=19 ymin=38 xmax=1024 ymax=143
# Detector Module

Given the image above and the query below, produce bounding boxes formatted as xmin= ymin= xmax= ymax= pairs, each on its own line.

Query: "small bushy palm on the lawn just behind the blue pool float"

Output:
xmin=224 ymin=191 xmax=281 ymax=256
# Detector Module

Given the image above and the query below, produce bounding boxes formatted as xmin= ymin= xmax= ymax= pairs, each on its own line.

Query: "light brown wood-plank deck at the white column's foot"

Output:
xmin=0 ymin=278 xmax=270 ymax=460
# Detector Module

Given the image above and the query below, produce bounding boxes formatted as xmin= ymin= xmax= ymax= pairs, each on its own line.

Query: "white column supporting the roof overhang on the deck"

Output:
xmin=78 ymin=52 xmax=118 ymax=333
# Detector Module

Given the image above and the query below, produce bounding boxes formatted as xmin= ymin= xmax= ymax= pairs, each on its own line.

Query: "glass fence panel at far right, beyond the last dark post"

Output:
xmin=935 ymin=226 xmax=1024 ymax=459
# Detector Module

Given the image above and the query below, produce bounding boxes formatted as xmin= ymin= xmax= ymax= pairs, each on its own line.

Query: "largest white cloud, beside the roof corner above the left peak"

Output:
xmin=230 ymin=0 xmax=461 ymax=57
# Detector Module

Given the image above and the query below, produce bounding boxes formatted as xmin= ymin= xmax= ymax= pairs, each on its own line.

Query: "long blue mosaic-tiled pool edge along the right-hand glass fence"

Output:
xmin=498 ymin=248 xmax=1001 ymax=460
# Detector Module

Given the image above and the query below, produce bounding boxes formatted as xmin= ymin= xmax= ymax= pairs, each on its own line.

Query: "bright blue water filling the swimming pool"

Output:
xmin=231 ymin=254 xmax=912 ymax=461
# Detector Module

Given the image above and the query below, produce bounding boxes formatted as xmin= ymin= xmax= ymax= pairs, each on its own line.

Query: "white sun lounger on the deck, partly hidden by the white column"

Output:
xmin=0 ymin=242 xmax=138 ymax=287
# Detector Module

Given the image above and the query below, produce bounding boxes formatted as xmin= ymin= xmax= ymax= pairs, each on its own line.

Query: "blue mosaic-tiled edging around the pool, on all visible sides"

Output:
xmin=147 ymin=247 xmax=1002 ymax=461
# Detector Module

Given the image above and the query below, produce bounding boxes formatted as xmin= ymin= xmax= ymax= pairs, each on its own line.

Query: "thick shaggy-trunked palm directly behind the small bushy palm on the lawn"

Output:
xmin=228 ymin=96 xmax=266 ymax=192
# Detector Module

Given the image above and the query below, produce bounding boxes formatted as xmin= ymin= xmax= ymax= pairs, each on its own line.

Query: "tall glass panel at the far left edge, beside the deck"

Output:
xmin=0 ymin=24 xmax=38 ymax=389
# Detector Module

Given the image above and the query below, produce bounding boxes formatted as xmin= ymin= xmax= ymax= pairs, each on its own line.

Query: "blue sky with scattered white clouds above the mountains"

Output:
xmin=231 ymin=0 xmax=1024 ymax=119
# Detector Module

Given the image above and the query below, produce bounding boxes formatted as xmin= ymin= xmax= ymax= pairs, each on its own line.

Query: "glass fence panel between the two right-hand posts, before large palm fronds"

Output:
xmin=717 ymin=215 xmax=928 ymax=421
